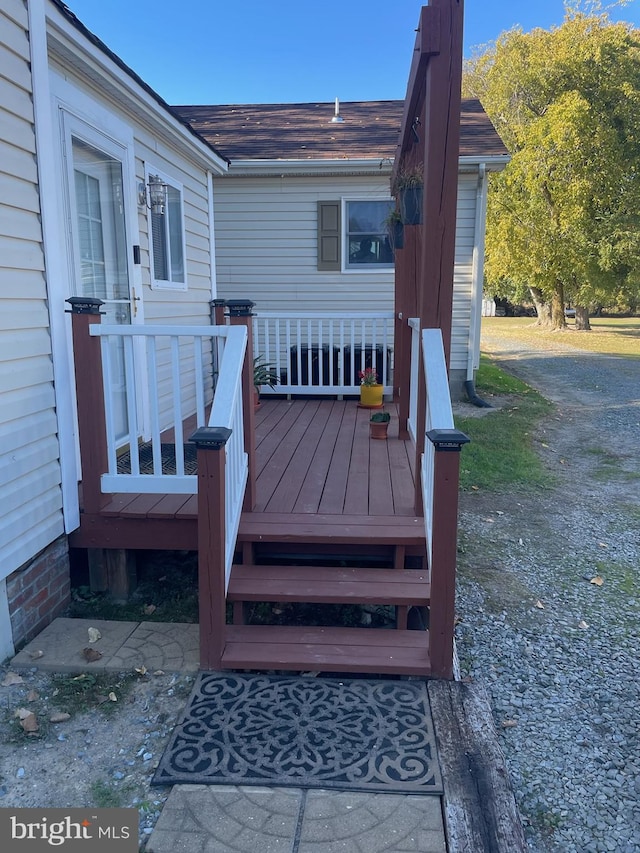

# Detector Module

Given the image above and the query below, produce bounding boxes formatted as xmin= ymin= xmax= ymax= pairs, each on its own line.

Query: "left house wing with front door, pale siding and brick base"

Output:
xmin=0 ymin=0 xmax=227 ymax=659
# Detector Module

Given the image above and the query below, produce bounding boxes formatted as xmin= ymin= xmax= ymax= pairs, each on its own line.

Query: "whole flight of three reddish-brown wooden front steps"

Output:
xmin=222 ymin=513 xmax=431 ymax=676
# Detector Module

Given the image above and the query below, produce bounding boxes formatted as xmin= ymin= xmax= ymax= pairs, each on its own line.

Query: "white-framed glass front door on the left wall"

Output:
xmin=67 ymin=119 xmax=135 ymax=444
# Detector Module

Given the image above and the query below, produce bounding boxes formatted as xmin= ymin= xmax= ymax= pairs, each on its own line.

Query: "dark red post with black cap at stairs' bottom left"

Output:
xmin=189 ymin=427 xmax=231 ymax=670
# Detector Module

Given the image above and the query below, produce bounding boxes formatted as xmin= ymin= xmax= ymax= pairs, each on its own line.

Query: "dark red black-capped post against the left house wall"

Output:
xmin=66 ymin=296 xmax=109 ymax=513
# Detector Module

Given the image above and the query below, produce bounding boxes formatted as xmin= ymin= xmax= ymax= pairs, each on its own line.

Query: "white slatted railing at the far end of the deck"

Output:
xmin=253 ymin=311 xmax=394 ymax=395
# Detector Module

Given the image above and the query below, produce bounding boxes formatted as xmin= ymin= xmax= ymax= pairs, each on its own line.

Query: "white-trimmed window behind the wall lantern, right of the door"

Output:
xmin=146 ymin=168 xmax=187 ymax=290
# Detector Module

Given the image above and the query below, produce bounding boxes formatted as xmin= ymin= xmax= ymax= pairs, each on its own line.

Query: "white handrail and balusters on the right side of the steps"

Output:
xmin=412 ymin=329 xmax=454 ymax=566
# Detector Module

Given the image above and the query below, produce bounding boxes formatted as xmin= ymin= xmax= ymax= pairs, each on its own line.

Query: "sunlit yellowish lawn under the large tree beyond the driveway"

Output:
xmin=482 ymin=317 xmax=640 ymax=358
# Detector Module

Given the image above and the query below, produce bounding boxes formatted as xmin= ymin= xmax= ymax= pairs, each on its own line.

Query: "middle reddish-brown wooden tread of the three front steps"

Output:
xmin=227 ymin=566 xmax=430 ymax=606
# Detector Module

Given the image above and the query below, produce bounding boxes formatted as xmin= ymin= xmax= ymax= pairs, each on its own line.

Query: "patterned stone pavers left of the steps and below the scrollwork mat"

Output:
xmin=12 ymin=618 xmax=447 ymax=853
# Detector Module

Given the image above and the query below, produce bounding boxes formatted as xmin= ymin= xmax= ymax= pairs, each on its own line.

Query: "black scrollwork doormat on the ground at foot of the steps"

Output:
xmin=152 ymin=673 xmax=442 ymax=794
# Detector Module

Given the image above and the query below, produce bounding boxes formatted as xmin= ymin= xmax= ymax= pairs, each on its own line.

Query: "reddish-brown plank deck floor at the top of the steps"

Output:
xmin=71 ymin=398 xmax=424 ymax=550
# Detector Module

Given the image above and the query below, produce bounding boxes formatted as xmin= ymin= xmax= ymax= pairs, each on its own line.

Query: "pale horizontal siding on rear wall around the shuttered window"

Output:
xmin=215 ymin=174 xmax=477 ymax=369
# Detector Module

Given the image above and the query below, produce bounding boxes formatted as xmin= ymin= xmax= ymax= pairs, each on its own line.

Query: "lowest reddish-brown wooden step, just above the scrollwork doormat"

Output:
xmin=222 ymin=625 xmax=431 ymax=675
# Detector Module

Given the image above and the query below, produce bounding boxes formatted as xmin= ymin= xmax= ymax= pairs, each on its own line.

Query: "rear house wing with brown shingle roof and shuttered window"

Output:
xmin=176 ymin=100 xmax=508 ymax=396
